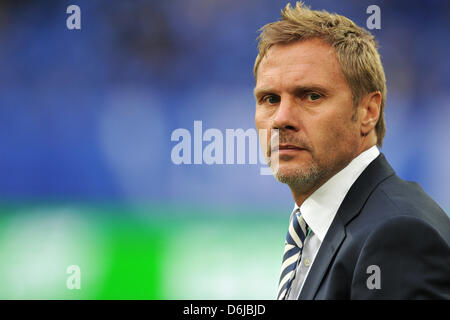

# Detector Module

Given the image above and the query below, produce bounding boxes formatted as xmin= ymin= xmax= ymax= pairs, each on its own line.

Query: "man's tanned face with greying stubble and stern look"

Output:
xmin=255 ymin=39 xmax=361 ymax=190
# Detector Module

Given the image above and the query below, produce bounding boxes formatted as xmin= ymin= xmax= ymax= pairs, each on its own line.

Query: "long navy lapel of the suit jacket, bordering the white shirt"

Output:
xmin=299 ymin=154 xmax=394 ymax=300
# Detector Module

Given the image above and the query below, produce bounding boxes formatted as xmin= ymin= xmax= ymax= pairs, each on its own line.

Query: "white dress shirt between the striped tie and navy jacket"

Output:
xmin=286 ymin=146 xmax=380 ymax=300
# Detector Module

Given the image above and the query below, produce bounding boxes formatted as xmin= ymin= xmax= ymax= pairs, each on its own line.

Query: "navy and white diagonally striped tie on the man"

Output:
xmin=277 ymin=210 xmax=308 ymax=300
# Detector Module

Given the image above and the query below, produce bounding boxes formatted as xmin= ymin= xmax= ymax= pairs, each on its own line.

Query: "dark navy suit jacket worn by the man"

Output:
xmin=299 ymin=154 xmax=450 ymax=299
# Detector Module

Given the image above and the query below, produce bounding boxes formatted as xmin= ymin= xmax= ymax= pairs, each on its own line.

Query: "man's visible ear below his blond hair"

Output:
xmin=359 ymin=91 xmax=381 ymax=136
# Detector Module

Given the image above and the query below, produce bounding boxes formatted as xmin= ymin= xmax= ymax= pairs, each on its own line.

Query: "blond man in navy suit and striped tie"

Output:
xmin=254 ymin=3 xmax=450 ymax=299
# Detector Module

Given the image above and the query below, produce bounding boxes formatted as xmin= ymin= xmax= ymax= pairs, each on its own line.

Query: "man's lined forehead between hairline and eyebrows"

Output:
xmin=256 ymin=39 xmax=346 ymax=88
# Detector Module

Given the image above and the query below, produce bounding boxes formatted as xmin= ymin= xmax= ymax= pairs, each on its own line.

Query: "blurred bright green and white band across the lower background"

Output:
xmin=0 ymin=204 xmax=285 ymax=299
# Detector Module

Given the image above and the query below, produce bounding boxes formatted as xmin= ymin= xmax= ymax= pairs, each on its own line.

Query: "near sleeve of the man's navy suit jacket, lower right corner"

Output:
xmin=351 ymin=215 xmax=450 ymax=299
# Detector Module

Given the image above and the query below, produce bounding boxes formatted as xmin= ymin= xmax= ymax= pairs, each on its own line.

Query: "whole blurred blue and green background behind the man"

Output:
xmin=0 ymin=0 xmax=450 ymax=299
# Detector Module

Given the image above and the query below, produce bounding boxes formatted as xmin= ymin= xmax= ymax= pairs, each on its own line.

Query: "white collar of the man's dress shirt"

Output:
xmin=291 ymin=146 xmax=380 ymax=242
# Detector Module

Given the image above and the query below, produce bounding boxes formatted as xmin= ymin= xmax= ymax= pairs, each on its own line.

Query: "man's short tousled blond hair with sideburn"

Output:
xmin=253 ymin=2 xmax=386 ymax=147
